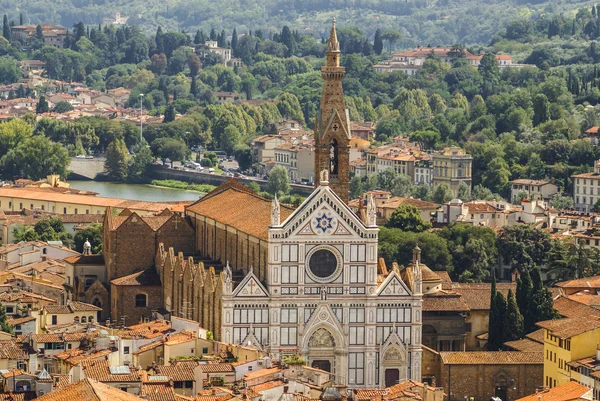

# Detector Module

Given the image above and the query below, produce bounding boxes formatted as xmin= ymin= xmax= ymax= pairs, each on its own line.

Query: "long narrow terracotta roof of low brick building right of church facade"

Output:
xmin=440 ymin=351 xmax=544 ymax=365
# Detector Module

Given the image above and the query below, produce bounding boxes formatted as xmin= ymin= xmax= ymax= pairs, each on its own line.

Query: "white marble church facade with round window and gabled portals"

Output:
xmin=221 ymin=180 xmax=422 ymax=388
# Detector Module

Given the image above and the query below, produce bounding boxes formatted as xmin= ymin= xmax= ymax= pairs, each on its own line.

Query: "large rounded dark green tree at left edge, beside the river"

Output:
xmin=0 ymin=136 xmax=70 ymax=180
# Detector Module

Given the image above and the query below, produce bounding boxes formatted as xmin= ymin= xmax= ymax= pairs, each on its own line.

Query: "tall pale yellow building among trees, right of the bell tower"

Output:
xmin=431 ymin=146 xmax=473 ymax=196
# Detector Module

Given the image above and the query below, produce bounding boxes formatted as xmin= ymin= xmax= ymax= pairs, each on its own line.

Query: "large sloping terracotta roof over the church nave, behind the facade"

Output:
xmin=186 ymin=179 xmax=293 ymax=240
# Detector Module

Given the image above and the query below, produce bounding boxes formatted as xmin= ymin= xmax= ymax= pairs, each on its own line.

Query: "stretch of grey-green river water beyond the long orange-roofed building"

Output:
xmin=69 ymin=181 xmax=203 ymax=202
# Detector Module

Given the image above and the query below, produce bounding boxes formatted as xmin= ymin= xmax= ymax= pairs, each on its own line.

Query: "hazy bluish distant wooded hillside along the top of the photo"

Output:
xmin=7 ymin=0 xmax=593 ymax=48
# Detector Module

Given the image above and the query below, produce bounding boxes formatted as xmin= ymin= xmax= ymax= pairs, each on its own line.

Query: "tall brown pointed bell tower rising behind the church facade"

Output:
xmin=314 ymin=18 xmax=351 ymax=203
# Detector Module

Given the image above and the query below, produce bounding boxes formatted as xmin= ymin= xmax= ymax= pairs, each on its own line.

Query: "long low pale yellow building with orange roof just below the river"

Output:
xmin=0 ymin=187 xmax=183 ymax=215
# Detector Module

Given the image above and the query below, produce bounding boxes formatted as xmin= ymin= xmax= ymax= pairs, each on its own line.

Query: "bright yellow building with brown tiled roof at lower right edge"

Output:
xmin=537 ymin=316 xmax=600 ymax=387
